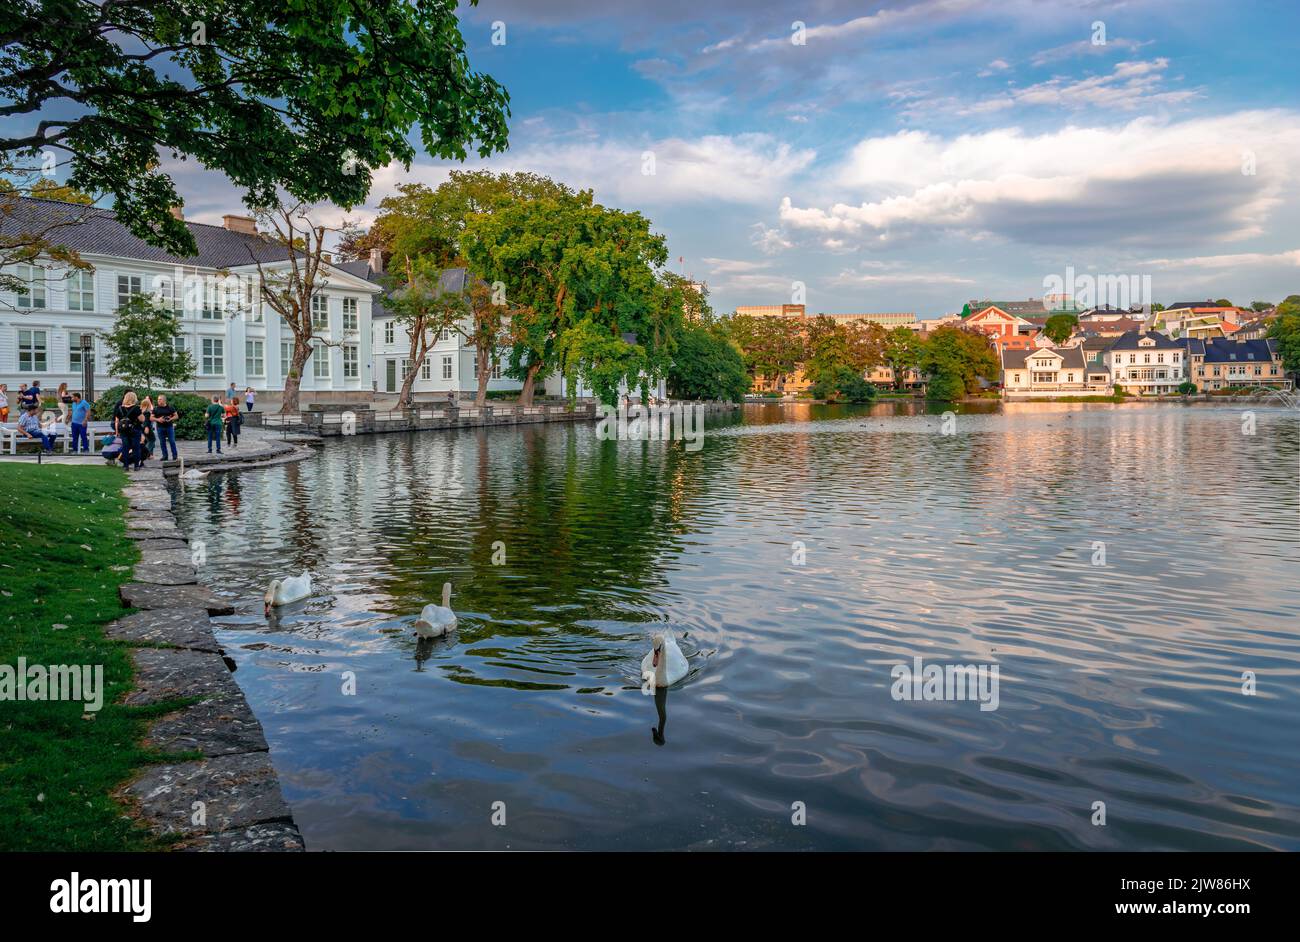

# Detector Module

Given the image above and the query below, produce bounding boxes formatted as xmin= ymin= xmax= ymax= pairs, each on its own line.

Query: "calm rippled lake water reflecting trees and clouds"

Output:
xmin=177 ymin=404 xmax=1300 ymax=850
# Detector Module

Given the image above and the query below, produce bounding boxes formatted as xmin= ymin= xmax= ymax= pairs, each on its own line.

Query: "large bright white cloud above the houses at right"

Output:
xmin=780 ymin=112 xmax=1300 ymax=244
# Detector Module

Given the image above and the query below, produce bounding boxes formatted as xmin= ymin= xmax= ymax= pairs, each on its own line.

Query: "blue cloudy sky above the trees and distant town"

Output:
xmin=179 ymin=0 xmax=1300 ymax=317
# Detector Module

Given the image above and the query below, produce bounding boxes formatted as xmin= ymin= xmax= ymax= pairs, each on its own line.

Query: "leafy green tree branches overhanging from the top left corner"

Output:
xmin=0 ymin=0 xmax=508 ymax=271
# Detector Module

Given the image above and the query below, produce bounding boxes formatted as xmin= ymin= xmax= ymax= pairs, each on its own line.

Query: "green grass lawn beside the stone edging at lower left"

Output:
xmin=0 ymin=463 xmax=187 ymax=851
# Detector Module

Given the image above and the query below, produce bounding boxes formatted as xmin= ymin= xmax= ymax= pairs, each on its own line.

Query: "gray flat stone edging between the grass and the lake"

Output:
xmin=105 ymin=465 xmax=303 ymax=851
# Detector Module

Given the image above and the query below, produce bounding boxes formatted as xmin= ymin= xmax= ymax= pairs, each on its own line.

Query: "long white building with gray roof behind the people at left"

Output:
xmin=0 ymin=197 xmax=381 ymax=401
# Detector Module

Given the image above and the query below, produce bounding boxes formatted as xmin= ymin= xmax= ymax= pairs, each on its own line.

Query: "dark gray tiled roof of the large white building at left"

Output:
xmin=0 ymin=196 xmax=289 ymax=268
